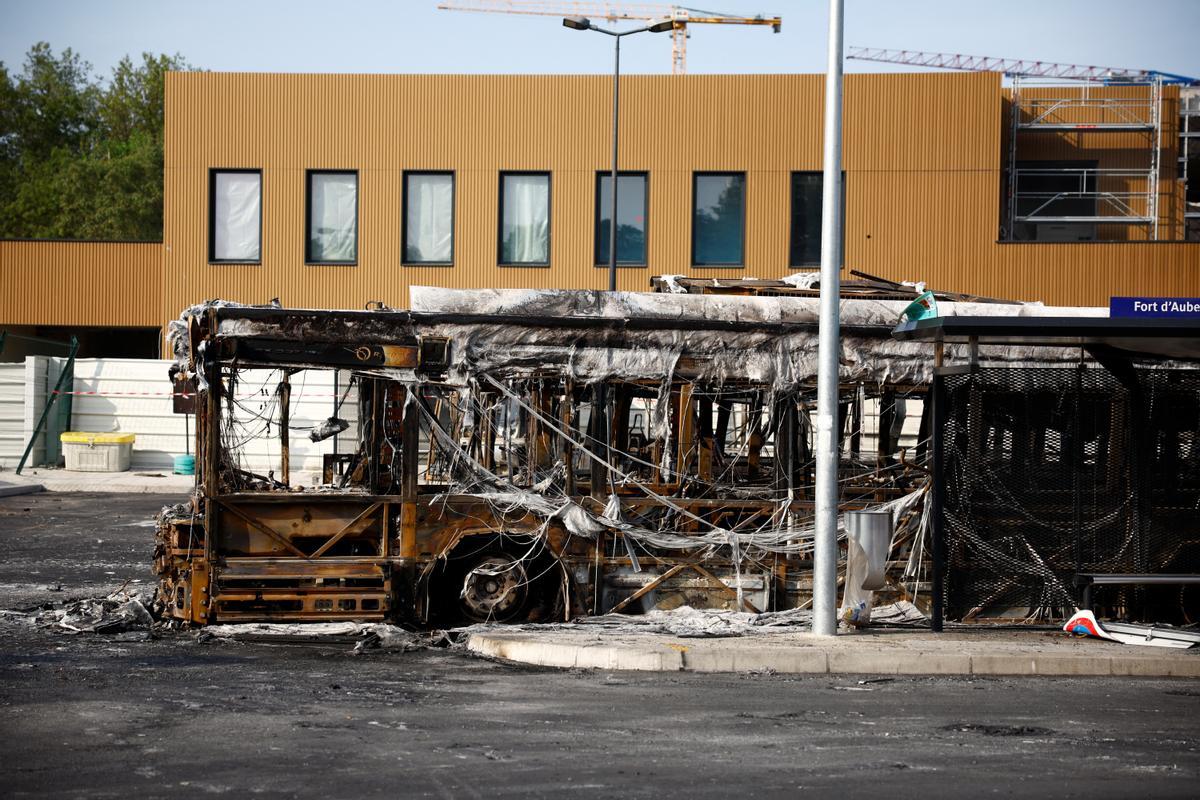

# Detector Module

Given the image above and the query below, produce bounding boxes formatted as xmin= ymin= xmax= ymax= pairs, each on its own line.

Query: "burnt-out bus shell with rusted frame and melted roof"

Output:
xmin=155 ymin=288 xmax=1065 ymax=624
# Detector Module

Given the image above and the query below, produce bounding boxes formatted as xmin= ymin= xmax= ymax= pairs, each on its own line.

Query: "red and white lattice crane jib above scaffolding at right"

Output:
xmin=846 ymin=47 xmax=1200 ymax=85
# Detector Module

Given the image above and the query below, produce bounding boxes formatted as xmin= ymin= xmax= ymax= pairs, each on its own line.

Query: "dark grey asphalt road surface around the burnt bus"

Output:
xmin=0 ymin=494 xmax=1200 ymax=799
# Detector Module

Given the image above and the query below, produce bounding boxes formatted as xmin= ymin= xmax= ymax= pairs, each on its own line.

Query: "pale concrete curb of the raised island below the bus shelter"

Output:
xmin=467 ymin=632 xmax=1200 ymax=678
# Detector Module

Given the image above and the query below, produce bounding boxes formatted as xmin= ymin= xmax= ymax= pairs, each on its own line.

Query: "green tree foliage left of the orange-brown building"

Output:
xmin=0 ymin=42 xmax=192 ymax=240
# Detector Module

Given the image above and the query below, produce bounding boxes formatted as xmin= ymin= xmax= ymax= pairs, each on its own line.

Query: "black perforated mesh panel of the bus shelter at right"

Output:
xmin=942 ymin=366 xmax=1200 ymax=622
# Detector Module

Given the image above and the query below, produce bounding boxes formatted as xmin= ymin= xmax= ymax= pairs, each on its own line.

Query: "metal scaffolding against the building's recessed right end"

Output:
xmin=1006 ymin=76 xmax=1163 ymax=240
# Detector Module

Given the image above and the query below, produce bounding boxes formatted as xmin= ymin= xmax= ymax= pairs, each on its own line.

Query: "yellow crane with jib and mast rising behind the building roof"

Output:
xmin=438 ymin=0 xmax=784 ymax=76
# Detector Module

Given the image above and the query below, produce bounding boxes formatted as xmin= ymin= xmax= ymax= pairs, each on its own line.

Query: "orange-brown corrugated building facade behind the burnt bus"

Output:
xmin=0 ymin=72 xmax=1200 ymax=357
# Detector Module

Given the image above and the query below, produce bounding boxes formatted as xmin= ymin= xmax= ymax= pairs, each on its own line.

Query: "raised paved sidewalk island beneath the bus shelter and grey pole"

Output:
xmin=467 ymin=626 xmax=1200 ymax=678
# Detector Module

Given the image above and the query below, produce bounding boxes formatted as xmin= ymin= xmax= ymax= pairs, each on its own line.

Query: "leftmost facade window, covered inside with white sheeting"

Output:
xmin=209 ymin=169 xmax=263 ymax=264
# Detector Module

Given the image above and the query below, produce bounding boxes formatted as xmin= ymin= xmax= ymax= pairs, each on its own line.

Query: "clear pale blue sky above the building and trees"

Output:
xmin=0 ymin=0 xmax=1200 ymax=77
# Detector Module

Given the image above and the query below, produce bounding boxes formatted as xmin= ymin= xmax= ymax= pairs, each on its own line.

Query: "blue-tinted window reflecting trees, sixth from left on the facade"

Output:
xmin=691 ymin=173 xmax=746 ymax=266
